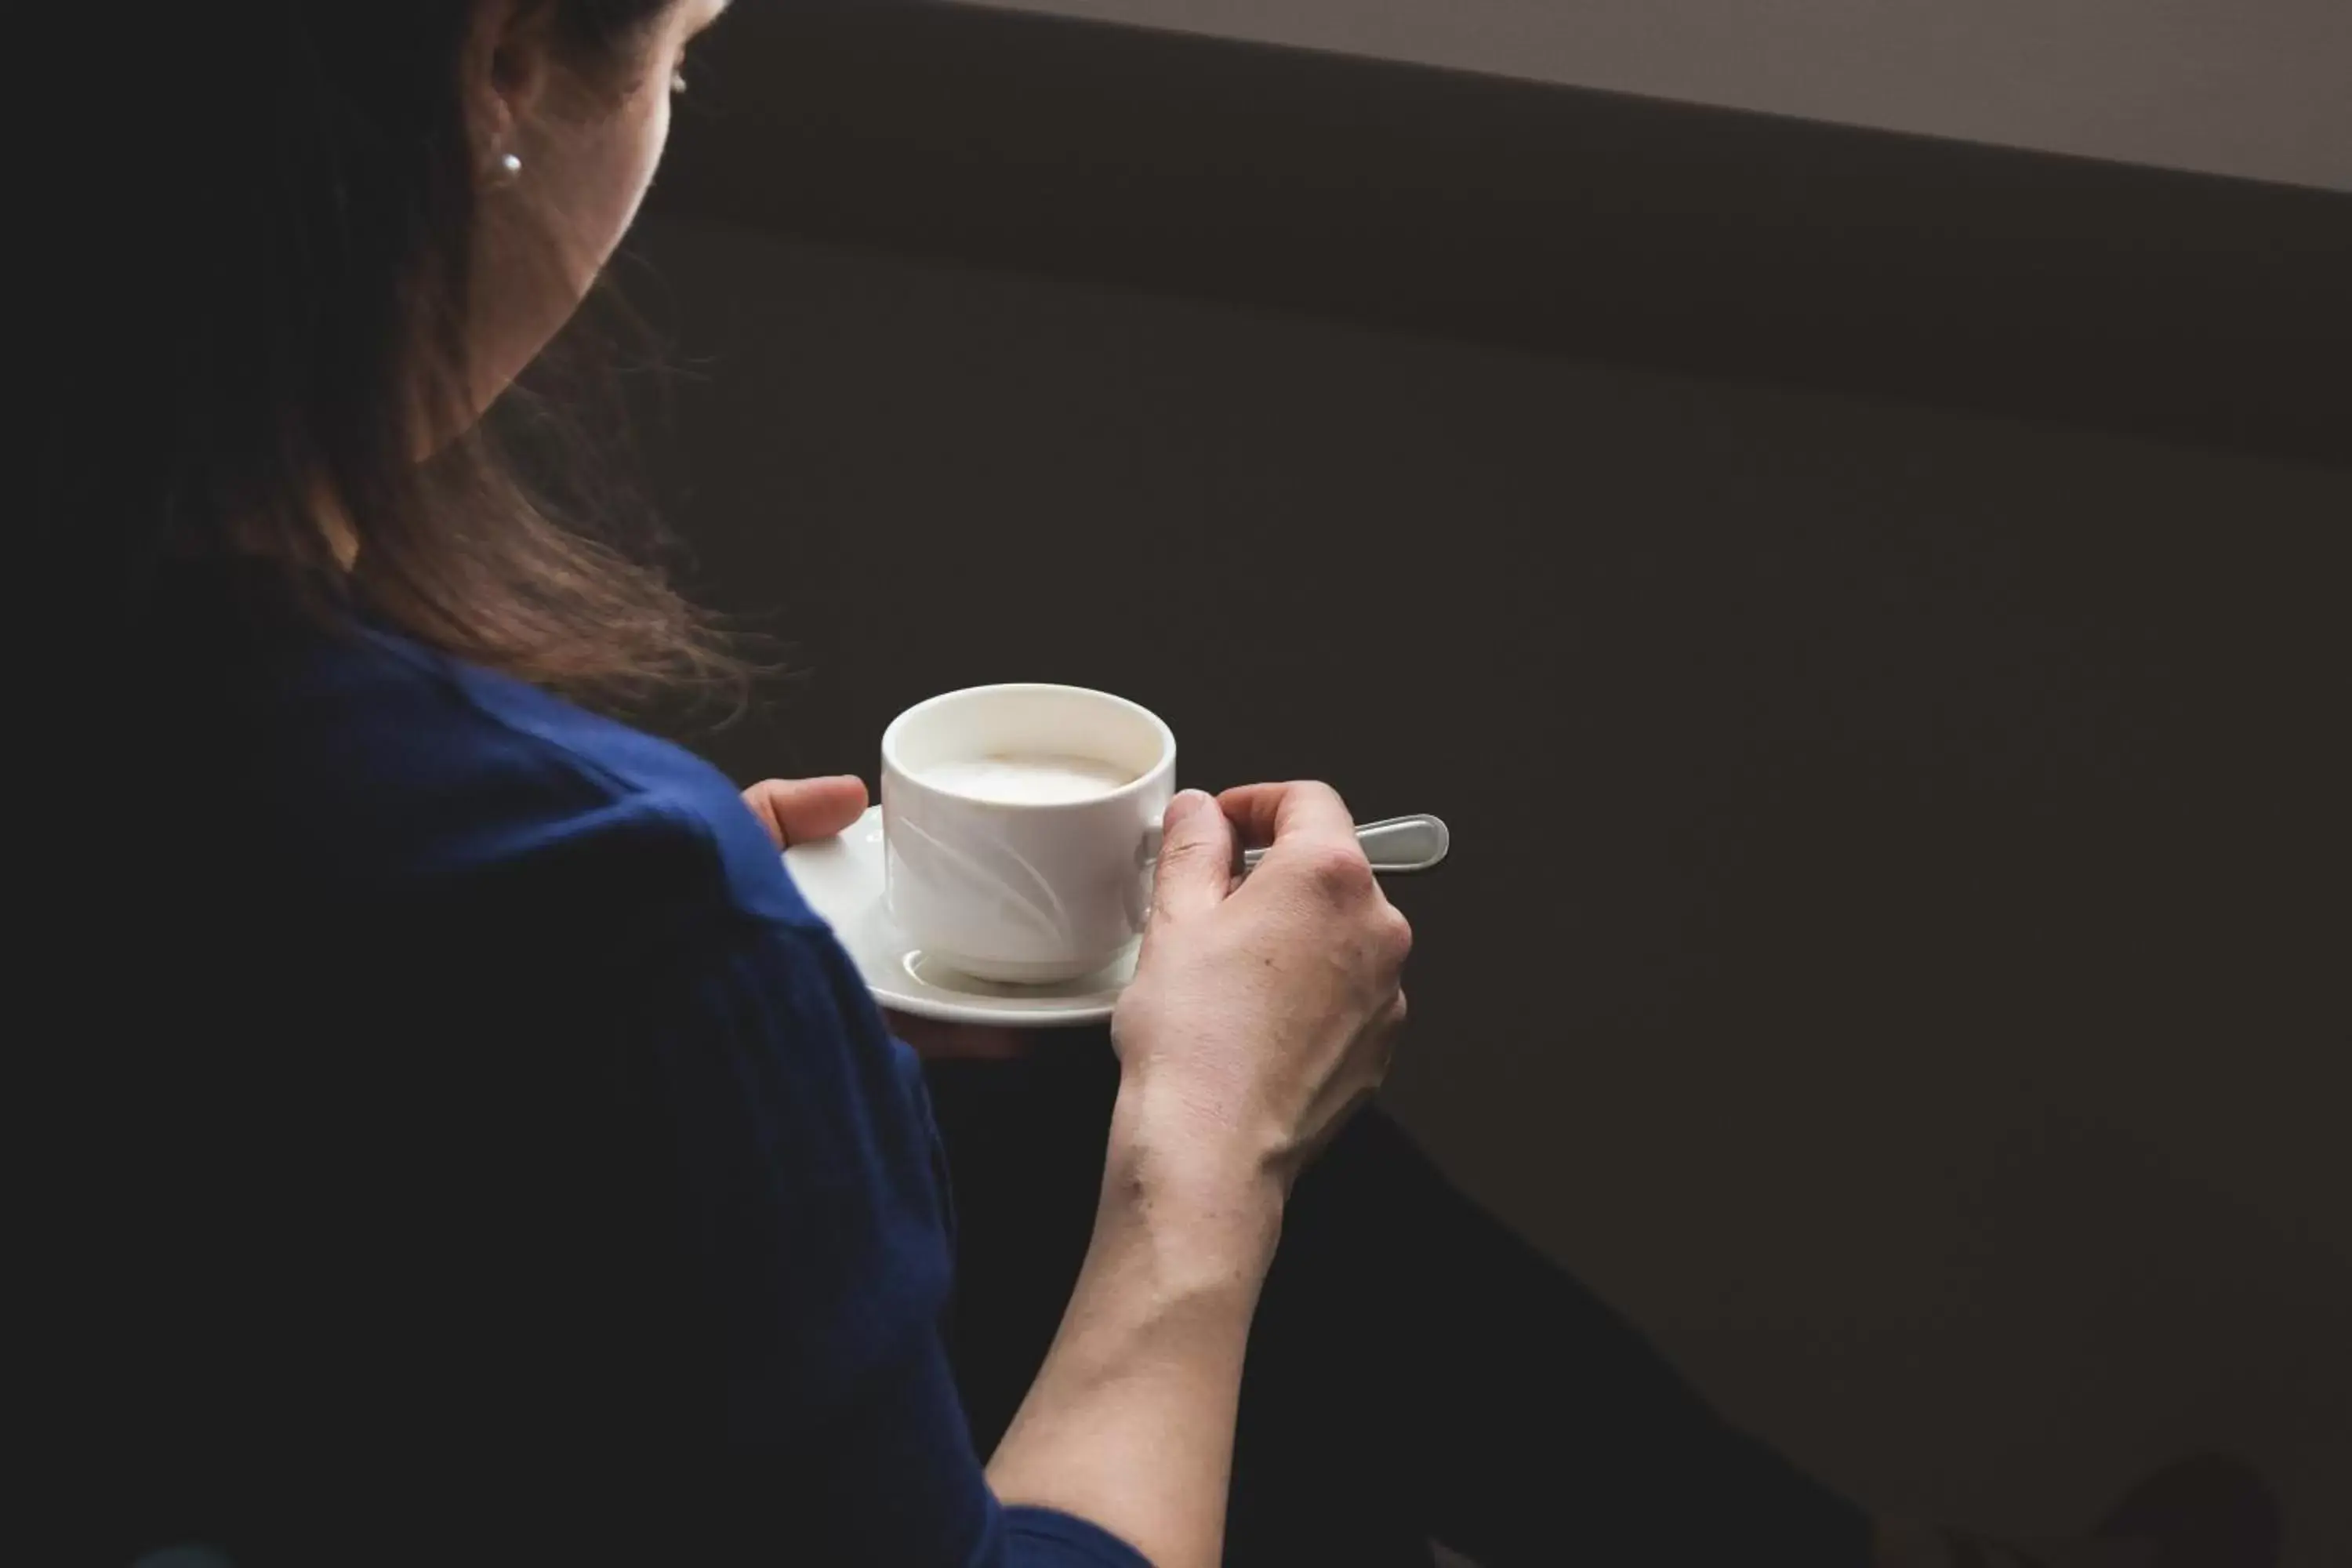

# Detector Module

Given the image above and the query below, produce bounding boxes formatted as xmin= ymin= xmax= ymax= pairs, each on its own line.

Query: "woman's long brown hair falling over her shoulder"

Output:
xmin=32 ymin=0 xmax=736 ymax=706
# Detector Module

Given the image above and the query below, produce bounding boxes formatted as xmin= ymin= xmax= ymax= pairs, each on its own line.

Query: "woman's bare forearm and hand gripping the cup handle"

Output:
xmin=988 ymin=785 xmax=1411 ymax=1568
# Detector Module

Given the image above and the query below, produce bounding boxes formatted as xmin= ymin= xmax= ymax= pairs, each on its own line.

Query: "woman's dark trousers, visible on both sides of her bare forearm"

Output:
xmin=929 ymin=1034 xmax=1870 ymax=1568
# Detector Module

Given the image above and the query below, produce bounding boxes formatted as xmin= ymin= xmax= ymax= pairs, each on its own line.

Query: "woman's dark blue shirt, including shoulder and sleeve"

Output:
xmin=56 ymin=567 xmax=1141 ymax=1568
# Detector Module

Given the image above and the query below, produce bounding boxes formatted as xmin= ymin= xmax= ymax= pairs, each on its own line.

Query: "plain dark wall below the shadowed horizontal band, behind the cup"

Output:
xmin=640 ymin=223 xmax=2352 ymax=1563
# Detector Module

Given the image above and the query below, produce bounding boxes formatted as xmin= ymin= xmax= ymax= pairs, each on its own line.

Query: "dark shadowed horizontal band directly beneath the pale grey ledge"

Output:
xmin=656 ymin=0 xmax=2352 ymax=466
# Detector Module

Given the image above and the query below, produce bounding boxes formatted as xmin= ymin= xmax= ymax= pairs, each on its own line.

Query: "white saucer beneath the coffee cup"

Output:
xmin=783 ymin=806 xmax=1136 ymax=1029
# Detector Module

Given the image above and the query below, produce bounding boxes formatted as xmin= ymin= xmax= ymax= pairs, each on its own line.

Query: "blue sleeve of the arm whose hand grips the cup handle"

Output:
xmin=616 ymin=888 xmax=1143 ymax=1568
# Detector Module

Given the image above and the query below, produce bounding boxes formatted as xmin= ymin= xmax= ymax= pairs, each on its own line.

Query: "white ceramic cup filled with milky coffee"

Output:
xmin=882 ymin=684 xmax=1176 ymax=985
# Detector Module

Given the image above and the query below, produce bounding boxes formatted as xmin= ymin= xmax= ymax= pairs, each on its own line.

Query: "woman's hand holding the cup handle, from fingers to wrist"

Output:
xmin=1112 ymin=783 xmax=1414 ymax=1189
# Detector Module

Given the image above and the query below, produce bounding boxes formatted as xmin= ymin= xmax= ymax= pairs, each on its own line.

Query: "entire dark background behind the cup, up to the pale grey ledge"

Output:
xmin=630 ymin=5 xmax=2352 ymax=1563
